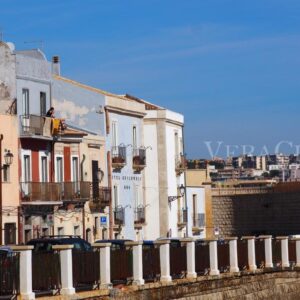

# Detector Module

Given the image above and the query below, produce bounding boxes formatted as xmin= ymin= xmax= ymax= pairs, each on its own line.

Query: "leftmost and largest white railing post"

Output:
xmin=11 ymin=246 xmax=35 ymax=300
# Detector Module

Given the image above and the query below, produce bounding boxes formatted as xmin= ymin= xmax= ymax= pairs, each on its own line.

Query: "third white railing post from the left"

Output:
xmin=92 ymin=243 xmax=112 ymax=289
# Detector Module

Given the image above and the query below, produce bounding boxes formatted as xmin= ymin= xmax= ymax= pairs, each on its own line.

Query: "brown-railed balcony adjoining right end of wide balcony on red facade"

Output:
xmin=60 ymin=181 xmax=91 ymax=203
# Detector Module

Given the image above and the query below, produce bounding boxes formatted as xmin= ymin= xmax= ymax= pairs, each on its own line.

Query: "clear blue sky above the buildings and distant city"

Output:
xmin=0 ymin=0 xmax=300 ymax=158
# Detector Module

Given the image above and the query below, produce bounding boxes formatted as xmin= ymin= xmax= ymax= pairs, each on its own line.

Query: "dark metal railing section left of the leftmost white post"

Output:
xmin=0 ymin=253 xmax=20 ymax=298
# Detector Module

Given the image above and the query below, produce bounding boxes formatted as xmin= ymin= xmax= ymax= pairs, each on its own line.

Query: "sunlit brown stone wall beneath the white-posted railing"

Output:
xmin=78 ymin=271 xmax=300 ymax=300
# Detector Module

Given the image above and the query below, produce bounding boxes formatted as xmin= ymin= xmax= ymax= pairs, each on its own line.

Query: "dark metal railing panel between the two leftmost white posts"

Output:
xmin=32 ymin=251 xmax=61 ymax=292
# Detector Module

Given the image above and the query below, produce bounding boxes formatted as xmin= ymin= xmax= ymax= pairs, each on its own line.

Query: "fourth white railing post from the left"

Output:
xmin=125 ymin=241 xmax=145 ymax=285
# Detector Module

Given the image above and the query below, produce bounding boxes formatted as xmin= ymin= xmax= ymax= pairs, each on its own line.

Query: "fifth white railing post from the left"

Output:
xmin=155 ymin=240 xmax=172 ymax=282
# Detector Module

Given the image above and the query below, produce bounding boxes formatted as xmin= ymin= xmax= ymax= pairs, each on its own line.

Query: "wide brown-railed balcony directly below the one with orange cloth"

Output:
xmin=20 ymin=182 xmax=62 ymax=204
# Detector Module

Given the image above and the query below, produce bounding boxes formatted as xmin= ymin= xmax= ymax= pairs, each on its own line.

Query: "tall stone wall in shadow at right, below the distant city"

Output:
xmin=212 ymin=183 xmax=300 ymax=237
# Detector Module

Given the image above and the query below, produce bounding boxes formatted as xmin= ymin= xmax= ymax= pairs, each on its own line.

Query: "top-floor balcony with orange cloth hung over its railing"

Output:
xmin=20 ymin=115 xmax=65 ymax=138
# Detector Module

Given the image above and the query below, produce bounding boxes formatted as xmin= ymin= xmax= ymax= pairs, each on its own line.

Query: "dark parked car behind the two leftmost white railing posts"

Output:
xmin=27 ymin=235 xmax=92 ymax=252
